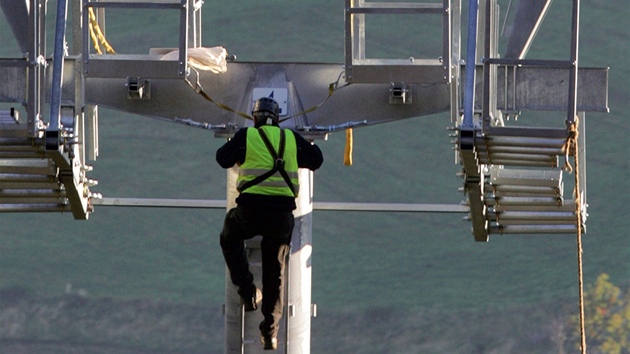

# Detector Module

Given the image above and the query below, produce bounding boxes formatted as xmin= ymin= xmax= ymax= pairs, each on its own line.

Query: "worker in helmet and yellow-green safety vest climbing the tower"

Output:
xmin=216 ymin=97 xmax=324 ymax=349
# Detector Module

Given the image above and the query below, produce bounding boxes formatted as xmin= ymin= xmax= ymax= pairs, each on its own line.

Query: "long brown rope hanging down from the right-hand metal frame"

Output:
xmin=563 ymin=116 xmax=586 ymax=354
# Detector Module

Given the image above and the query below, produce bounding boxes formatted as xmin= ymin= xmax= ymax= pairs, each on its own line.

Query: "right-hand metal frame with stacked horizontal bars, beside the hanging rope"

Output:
xmin=455 ymin=0 xmax=608 ymax=241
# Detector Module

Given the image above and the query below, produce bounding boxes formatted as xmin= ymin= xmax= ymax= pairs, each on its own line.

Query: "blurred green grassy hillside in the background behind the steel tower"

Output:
xmin=0 ymin=0 xmax=630 ymax=353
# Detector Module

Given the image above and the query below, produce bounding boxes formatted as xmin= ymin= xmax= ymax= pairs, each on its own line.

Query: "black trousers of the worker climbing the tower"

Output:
xmin=220 ymin=206 xmax=295 ymax=337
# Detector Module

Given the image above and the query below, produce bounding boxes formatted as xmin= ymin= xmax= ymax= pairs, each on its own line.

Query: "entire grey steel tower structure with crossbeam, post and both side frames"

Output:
xmin=0 ymin=0 xmax=608 ymax=353
